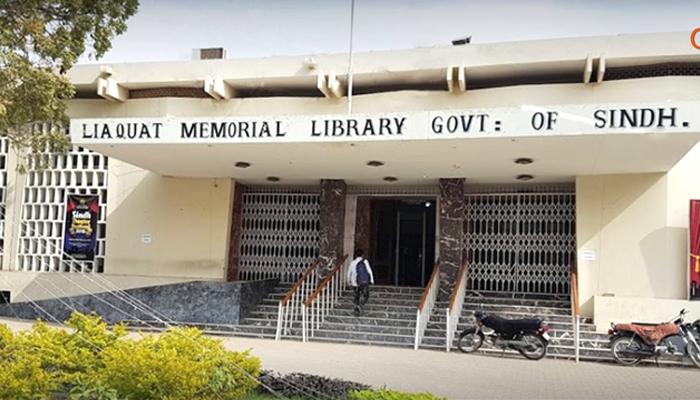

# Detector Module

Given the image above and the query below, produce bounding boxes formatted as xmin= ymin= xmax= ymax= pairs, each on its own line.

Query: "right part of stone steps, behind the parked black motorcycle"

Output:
xmin=421 ymin=291 xmax=611 ymax=360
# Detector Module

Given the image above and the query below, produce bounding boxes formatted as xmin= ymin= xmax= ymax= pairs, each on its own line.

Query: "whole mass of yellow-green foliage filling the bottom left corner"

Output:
xmin=0 ymin=313 xmax=260 ymax=400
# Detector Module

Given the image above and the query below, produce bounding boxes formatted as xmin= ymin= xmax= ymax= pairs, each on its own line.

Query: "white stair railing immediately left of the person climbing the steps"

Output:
xmin=301 ymin=254 xmax=348 ymax=342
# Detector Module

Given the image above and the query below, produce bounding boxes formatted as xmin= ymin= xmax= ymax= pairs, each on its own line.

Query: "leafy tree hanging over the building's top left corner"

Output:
xmin=0 ymin=0 xmax=139 ymax=169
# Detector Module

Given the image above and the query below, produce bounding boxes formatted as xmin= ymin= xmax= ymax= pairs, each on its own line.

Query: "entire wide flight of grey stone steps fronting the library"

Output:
xmin=234 ymin=285 xmax=611 ymax=360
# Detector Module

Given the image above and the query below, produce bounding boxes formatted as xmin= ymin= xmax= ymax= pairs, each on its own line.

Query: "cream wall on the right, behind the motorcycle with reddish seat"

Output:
xmin=576 ymin=142 xmax=700 ymax=330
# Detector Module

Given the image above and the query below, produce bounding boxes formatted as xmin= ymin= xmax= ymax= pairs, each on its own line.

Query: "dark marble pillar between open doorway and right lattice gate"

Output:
xmin=440 ymin=178 xmax=464 ymax=298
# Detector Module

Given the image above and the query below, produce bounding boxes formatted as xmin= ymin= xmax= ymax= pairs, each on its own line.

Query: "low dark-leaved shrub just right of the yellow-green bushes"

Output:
xmin=258 ymin=371 xmax=369 ymax=399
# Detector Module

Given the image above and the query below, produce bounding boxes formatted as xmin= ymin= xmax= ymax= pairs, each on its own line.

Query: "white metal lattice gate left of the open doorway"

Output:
xmin=239 ymin=191 xmax=319 ymax=282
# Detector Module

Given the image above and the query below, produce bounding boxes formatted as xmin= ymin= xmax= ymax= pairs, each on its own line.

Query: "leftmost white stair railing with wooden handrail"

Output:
xmin=275 ymin=261 xmax=319 ymax=340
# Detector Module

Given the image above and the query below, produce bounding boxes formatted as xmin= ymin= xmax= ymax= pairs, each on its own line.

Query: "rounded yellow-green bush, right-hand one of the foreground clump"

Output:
xmin=91 ymin=328 xmax=260 ymax=400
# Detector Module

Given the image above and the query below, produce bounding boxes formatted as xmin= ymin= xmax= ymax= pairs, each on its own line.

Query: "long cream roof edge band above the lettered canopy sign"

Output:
xmin=68 ymin=32 xmax=700 ymax=97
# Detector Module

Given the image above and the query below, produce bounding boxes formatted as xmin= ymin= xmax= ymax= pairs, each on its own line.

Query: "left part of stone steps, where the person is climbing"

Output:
xmin=234 ymin=285 xmax=426 ymax=348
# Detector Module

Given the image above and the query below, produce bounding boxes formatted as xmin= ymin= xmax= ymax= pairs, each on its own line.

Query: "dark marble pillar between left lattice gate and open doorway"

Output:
xmin=319 ymin=179 xmax=347 ymax=276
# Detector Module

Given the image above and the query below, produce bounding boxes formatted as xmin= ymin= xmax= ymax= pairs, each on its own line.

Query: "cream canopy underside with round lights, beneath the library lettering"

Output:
xmin=79 ymin=132 xmax=700 ymax=185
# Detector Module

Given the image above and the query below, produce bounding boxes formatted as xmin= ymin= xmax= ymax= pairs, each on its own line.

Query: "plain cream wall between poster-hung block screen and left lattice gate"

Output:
xmin=105 ymin=159 xmax=232 ymax=279
